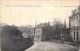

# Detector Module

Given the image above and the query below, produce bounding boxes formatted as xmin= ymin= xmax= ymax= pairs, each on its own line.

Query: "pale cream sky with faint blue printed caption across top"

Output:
xmin=0 ymin=0 xmax=79 ymax=26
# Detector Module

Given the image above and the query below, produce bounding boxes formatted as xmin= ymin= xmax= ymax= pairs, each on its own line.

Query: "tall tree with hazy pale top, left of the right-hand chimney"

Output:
xmin=47 ymin=19 xmax=64 ymax=40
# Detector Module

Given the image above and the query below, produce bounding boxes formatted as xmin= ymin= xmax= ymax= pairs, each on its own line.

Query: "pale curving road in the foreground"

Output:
xmin=25 ymin=41 xmax=78 ymax=51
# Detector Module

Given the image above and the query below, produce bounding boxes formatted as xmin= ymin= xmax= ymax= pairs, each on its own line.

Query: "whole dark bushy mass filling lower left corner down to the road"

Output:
xmin=1 ymin=25 xmax=33 ymax=51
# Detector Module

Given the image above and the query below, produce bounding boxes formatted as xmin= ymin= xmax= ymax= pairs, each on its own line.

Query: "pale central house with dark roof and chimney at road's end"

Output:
xmin=34 ymin=22 xmax=50 ymax=41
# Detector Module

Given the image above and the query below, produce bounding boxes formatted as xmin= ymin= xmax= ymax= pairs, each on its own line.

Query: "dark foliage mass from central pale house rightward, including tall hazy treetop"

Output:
xmin=43 ymin=20 xmax=64 ymax=39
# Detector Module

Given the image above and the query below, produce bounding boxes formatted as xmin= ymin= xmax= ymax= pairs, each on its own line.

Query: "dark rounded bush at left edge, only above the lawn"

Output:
xmin=1 ymin=25 xmax=23 ymax=38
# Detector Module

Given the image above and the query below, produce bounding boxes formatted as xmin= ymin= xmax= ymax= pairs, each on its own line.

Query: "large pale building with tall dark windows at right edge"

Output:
xmin=69 ymin=6 xmax=80 ymax=42
